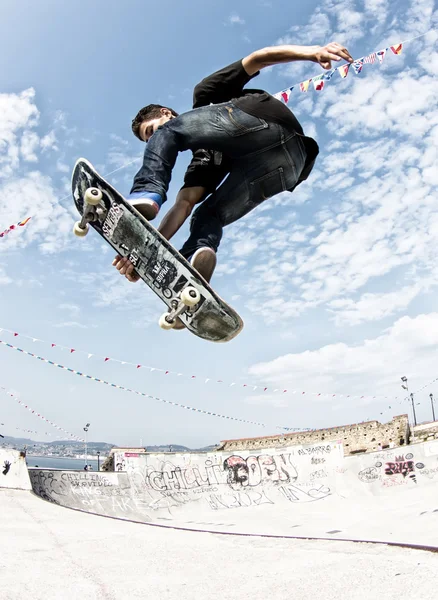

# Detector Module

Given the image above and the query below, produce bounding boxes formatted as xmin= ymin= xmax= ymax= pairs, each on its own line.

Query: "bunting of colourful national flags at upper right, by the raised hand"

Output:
xmin=273 ymin=29 xmax=435 ymax=104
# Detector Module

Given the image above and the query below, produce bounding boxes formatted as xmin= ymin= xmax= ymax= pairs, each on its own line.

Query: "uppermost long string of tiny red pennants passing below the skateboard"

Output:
xmin=0 ymin=328 xmax=398 ymax=400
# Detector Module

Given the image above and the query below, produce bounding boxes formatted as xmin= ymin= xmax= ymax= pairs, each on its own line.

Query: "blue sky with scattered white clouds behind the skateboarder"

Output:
xmin=0 ymin=0 xmax=438 ymax=446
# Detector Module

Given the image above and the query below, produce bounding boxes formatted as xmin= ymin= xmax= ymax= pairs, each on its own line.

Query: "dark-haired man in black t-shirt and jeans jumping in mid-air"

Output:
xmin=113 ymin=42 xmax=353 ymax=281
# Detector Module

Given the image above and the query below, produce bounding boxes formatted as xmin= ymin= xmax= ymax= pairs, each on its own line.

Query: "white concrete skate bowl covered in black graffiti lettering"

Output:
xmin=24 ymin=441 xmax=438 ymax=550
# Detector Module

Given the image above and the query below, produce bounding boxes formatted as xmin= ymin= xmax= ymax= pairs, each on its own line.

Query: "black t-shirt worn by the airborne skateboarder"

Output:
xmin=183 ymin=60 xmax=319 ymax=192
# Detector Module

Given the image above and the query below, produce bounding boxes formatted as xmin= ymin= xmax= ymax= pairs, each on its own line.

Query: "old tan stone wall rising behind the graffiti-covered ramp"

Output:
xmin=217 ymin=415 xmax=408 ymax=456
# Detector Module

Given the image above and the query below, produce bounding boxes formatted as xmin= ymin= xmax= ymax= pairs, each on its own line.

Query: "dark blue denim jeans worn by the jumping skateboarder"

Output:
xmin=131 ymin=102 xmax=306 ymax=257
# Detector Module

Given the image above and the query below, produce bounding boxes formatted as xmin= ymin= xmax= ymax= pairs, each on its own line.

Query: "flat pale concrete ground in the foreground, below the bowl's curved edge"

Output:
xmin=0 ymin=489 xmax=438 ymax=600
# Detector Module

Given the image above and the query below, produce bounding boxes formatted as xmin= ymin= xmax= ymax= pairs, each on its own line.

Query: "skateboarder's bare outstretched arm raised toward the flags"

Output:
xmin=242 ymin=42 xmax=353 ymax=76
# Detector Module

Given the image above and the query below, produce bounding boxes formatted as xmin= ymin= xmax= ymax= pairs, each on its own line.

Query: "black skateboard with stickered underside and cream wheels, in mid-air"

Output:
xmin=72 ymin=158 xmax=243 ymax=342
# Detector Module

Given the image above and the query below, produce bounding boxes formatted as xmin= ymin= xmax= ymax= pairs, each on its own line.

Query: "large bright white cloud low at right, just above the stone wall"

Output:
xmin=249 ymin=313 xmax=438 ymax=406
